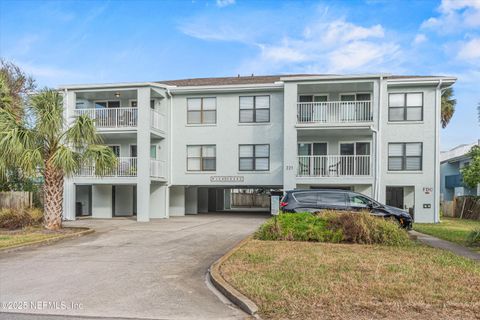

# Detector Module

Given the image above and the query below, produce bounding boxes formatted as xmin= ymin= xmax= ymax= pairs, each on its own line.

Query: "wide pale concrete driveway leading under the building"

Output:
xmin=0 ymin=213 xmax=268 ymax=319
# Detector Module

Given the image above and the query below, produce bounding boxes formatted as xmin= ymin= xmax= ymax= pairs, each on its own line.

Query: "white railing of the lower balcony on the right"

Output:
xmin=297 ymin=155 xmax=371 ymax=177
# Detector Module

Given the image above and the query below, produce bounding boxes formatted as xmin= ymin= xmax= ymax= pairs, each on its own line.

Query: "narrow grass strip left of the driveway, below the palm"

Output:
xmin=0 ymin=227 xmax=83 ymax=249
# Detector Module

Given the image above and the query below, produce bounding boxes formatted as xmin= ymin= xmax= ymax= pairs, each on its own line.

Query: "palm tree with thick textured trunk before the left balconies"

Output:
xmin=0 ymin=89 xmax=117 ymax=230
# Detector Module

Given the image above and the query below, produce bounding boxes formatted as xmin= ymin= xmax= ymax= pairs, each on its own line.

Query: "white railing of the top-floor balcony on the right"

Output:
xmin=297 ymin=101 xmax=373 ymax=124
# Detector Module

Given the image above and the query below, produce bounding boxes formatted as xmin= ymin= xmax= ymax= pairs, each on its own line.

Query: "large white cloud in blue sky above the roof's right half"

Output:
xmin=243 ymin=19 xmax=400 ymax=73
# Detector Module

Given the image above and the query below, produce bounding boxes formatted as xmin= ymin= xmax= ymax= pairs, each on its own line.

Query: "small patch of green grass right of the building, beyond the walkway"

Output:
xmin=413 ymin=218 xmax=480 ymax=249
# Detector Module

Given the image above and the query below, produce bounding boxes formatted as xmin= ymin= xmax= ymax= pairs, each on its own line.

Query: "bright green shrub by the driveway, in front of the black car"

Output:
xmin=255 ymin=212 xmax=342 ymax=243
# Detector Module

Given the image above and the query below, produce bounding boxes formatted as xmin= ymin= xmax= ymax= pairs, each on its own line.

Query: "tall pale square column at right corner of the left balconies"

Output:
xmin=137 ymin=88 xmax=150 ymax=221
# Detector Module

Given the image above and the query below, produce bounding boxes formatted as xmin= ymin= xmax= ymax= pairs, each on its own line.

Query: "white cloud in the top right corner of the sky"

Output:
xmin=421 ymin=0 xmax=480 ymax=33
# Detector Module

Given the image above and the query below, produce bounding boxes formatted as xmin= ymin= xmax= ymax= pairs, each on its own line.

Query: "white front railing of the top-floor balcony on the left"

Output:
xmin=75 ymin=108 xmax=138 ymax=128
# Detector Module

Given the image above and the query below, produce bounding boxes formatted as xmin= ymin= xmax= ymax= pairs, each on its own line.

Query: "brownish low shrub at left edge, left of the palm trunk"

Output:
xmin=0 ymin=208 xmax=43 ymax=230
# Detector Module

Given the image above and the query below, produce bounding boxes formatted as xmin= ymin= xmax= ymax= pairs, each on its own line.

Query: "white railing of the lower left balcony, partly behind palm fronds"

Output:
xmin=75 ymin=157 xmax=167 ymax=178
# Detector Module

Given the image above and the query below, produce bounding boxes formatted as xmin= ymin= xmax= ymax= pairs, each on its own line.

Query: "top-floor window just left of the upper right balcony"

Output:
xmin=240 ymin=96 xmax=270 ymax=123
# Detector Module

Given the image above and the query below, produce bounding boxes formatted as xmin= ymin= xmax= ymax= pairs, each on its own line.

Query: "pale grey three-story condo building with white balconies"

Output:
xmin=62 ymin=74 xmax=456 ymax=222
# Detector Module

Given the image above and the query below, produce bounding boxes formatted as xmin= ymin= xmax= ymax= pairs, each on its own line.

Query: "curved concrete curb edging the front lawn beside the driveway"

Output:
xmin=209 ymin=236 xmax=260 ymax=319
